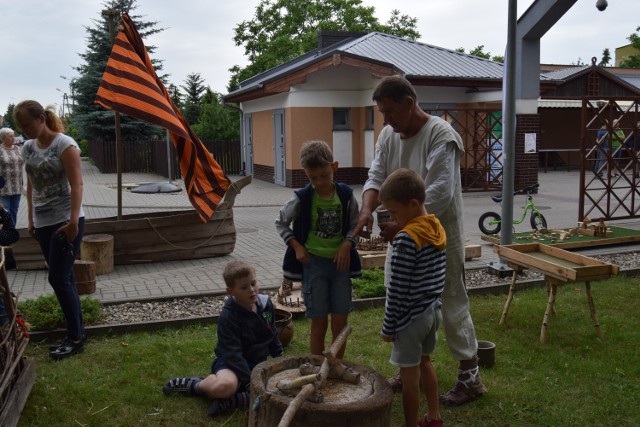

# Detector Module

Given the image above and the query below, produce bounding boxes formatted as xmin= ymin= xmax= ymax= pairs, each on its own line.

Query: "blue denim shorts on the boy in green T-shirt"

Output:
xmin=302 ymin=254 xmax=351 ymax=319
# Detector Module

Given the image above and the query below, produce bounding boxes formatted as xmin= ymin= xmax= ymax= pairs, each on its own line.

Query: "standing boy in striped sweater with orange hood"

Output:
xmin=378 ymin=169 xmax=447 ymax=427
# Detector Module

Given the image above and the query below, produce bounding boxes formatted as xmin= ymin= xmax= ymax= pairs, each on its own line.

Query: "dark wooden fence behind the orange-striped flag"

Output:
xmin=89 ymin=140 xmax=242 ymax=180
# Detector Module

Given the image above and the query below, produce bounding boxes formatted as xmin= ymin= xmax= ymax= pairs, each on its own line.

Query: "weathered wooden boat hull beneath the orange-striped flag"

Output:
xmin=13 ymin=209 xmax=236 ymax=270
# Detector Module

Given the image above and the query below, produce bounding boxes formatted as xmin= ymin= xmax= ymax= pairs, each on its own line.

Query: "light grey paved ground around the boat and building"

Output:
xmin=8 ymin=160 xmax=640 ymax=303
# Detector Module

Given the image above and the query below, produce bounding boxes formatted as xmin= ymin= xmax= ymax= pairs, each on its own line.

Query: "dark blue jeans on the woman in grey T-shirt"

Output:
xmin=35 ymin=218 xmax=84 ymax=341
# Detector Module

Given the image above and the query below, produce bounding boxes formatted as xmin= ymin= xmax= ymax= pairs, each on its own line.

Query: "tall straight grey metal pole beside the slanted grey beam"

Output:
xmin=500 ymin=0 xmax=518 ymax=245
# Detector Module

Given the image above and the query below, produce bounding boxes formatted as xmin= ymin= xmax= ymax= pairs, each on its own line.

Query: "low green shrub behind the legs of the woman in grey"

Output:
xmin=18 ymin=294 xmax=102 ymax=331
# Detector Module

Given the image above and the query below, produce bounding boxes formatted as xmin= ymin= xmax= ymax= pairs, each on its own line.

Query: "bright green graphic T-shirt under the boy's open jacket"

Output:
xmin=305 ymin=191 xmax=344 ymax=259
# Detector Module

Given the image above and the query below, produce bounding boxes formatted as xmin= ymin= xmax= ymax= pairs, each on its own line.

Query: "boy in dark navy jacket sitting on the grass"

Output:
xmin=162 ymin=261 xmax=283 ymax=416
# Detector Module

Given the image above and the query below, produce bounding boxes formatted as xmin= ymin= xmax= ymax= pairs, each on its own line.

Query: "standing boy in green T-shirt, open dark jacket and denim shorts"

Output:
xmin=276 ymin=141 xmax=362 ymax=359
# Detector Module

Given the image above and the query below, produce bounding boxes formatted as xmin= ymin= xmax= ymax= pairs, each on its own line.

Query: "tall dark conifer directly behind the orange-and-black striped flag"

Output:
xmin=71 ymin=0 xmax=163 ymax=142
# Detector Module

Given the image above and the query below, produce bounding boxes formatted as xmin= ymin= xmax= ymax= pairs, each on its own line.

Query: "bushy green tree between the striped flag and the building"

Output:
xmin=192 ymin=87 xmax=240 ymax=141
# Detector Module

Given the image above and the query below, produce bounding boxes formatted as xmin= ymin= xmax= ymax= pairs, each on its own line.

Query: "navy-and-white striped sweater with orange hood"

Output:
xmin=382 ymin=215 xmax=446 ymax=336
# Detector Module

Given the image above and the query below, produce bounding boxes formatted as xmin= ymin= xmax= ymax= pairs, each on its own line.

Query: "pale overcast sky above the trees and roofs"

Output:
xmin=0 ymin=0 xmax=640 ymax=114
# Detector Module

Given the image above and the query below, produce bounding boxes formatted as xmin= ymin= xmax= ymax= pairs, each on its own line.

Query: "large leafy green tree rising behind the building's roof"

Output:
xmin=227 ymin=0 xmax=420 ymax=91
